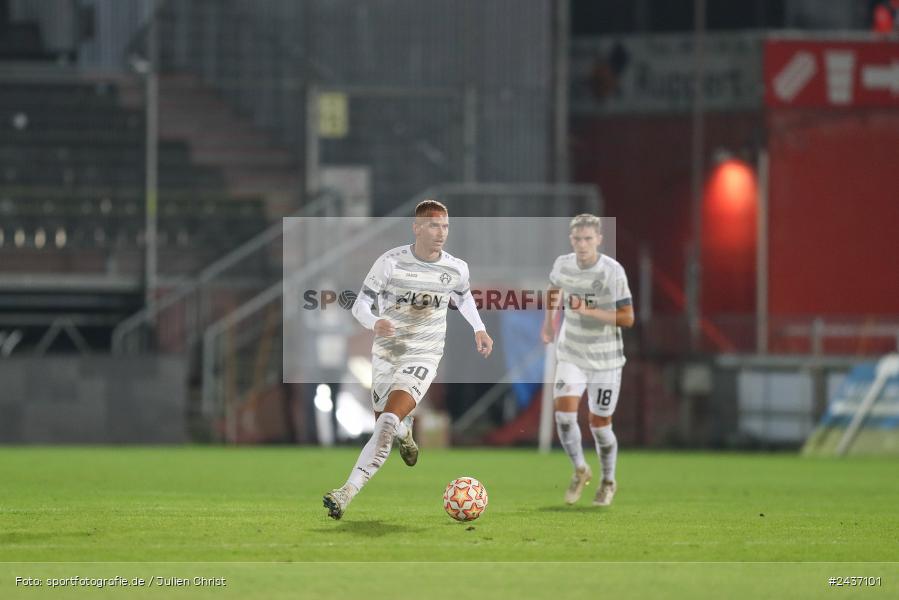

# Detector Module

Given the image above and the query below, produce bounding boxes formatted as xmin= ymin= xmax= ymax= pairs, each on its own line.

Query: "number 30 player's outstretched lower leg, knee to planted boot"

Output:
xmin=324 ymin=390 xmax=415 ymax=519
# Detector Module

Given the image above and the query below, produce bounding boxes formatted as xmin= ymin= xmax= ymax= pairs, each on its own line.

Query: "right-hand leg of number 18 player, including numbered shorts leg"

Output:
xmin=587 ymin=369 xmax=621 ymax=506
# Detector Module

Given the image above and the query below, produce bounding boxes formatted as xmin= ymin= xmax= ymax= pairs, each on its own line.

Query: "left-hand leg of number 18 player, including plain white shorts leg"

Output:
xmin=553 ymin=362 xmax=593 ymax=504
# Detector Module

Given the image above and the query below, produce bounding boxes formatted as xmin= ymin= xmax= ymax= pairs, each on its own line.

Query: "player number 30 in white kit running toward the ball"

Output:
xmin=324 ymin=200 xmax=493 ymax=519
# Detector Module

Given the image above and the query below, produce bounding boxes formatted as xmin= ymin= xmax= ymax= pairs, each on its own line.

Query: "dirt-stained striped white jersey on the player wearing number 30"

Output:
xmin=361 ymin=244 xmax=469 ymax=365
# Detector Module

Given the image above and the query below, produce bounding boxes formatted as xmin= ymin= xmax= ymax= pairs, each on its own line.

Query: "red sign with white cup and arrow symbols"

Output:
xmin=764 ymin=40 xmax=899 ymax=109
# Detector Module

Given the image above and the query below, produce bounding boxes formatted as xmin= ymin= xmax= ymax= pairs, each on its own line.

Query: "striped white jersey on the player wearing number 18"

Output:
xmin=549 ymin=252 xmax=632 ymax=371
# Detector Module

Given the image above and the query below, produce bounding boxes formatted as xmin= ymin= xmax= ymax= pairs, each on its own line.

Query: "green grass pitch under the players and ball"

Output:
xmin=0 ymin=447 xmax=899 ymax=599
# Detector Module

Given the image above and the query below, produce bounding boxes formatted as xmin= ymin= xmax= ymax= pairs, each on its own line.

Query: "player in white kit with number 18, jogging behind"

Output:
xmin=542 ymin=214 xmax=634 ymax=506
